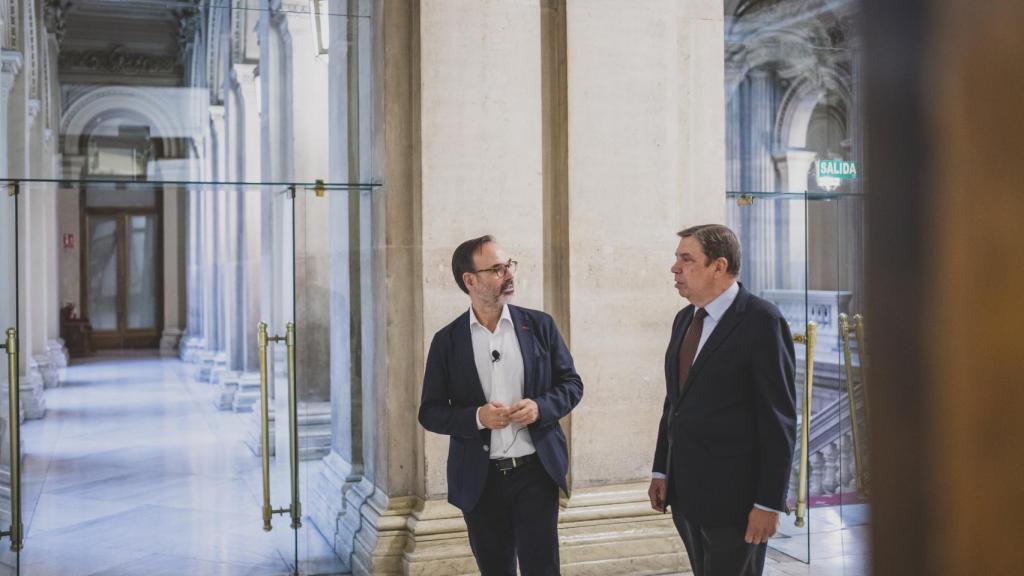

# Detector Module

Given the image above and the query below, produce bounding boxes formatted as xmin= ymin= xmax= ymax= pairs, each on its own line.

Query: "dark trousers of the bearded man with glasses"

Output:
xmin=463 ymin=458 xmax=559 ymax=576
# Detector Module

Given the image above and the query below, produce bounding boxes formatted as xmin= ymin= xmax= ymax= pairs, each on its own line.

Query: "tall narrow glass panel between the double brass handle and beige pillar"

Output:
xmin=295 ymin=180 xmax=378 ymax=574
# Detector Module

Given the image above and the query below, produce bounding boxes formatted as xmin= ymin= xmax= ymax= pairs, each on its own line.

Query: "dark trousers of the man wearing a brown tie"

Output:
xmin=672 ymin=506 xmax=768 ymax=576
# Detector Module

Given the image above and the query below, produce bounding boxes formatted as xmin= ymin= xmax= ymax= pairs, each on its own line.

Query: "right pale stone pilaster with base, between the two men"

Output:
xmin=560 ymin=0 xmax=725 ymax=574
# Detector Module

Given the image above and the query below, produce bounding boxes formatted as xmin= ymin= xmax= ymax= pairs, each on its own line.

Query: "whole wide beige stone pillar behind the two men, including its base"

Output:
xmin=339 ymin=0 xmax=725 ymax=574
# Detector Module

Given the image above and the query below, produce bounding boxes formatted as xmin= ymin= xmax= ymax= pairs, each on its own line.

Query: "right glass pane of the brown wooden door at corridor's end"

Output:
xmin=127 ymin=216 xmax=157 ymax=329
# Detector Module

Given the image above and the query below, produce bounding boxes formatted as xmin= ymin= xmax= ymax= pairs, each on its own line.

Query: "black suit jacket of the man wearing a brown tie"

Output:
xmin=653 ymin=286 xmax=797 ymax=526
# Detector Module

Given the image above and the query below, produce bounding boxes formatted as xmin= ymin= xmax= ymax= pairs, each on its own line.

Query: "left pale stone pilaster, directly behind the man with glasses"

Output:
xmin=391 ymin=0 xmax=548 ymax=574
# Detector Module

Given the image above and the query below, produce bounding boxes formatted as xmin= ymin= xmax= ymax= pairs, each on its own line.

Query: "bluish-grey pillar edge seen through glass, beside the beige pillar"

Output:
xmin=309 ymin=0 xmax=373 ymax=560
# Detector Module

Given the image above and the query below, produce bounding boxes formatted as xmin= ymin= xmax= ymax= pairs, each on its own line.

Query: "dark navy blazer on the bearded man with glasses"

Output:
xmin=420 ymin=304 xmax=583 ymax=512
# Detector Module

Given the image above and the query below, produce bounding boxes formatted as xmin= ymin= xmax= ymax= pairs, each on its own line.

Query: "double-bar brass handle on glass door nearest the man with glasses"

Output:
xmin=256 ymin=322 xmax=302 ymax=532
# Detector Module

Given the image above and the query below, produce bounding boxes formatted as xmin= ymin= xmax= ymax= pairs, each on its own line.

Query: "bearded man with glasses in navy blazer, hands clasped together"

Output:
xmin=420 ymin=236 xmax=583 ymax=576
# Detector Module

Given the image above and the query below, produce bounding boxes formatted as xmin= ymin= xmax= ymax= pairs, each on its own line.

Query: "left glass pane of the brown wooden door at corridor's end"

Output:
xmin=88 ymin=216 xmax=118 ymax=330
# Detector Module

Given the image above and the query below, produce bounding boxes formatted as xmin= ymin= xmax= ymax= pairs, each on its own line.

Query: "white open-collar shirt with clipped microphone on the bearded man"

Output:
xmin=469 ymin=305 xmax=537 ymax=460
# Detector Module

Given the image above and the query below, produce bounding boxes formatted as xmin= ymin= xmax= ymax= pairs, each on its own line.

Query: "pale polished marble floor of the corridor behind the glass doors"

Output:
xmin=7 ymin=353 xmax=345 ymax=576
